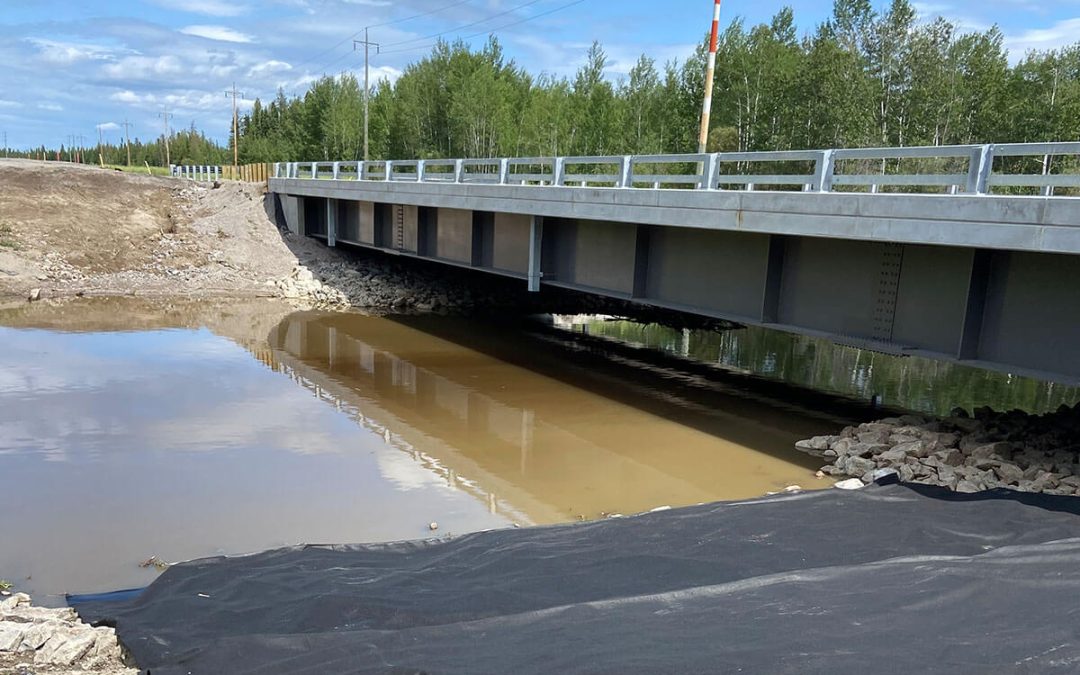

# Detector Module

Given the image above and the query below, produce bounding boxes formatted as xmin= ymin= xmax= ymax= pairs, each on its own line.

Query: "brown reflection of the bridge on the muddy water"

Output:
xmin=261 ymin=313 xmax=825 ymax=523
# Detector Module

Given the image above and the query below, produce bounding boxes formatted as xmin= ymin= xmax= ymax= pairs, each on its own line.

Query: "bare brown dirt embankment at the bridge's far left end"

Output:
xmin=0 ymin=160 xmax=349 ymax=297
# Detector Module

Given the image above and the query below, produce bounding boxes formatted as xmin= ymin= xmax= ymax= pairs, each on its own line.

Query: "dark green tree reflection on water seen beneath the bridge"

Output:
xmin=588 ymin=320 xmax=1080 ymax=414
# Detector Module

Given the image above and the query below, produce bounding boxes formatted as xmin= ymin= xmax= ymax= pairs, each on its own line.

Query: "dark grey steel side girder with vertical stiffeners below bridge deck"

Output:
xmin=279 ymin=194 xmax=1080 ymax=382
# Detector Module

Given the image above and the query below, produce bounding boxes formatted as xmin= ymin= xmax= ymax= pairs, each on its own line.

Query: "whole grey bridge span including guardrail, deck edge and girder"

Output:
xmin=259 ymin=143 xmax=1080 ymax=382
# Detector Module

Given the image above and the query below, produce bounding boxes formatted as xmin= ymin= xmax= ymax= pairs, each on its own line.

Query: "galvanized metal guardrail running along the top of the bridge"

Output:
xmin=273 ymin=143 xmax=1080 ymax=197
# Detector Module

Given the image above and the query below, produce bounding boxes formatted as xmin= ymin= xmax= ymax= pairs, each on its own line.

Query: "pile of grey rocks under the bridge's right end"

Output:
xmin=795 ymin=404 xmax=1080 ymax=495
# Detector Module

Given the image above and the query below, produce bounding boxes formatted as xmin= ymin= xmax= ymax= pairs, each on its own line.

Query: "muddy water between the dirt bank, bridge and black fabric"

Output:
xmin=0 ymin=299 xmax=843 ymax=604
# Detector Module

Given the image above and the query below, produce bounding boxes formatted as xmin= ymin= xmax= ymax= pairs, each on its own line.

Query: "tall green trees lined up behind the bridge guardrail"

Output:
xmin=240 ymin=0 xmax=1080 ymax=162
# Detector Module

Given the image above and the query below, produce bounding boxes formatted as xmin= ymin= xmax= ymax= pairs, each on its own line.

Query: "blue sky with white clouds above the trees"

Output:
xmin=0 ymin=0 xmax=1080 ymax=148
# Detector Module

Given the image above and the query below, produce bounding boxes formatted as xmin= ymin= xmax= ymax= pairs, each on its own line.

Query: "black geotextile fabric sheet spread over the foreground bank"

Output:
xmin=77 ymin=485 xmax=1080 ymax=675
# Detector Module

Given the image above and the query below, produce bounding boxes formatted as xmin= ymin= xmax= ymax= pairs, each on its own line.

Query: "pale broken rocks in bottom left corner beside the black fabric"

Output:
xmin=0 ymin=593 xmax=137 ymax=675
